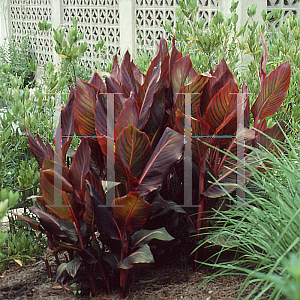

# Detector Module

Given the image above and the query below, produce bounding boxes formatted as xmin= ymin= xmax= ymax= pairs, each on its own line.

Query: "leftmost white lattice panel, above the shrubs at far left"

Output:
xmin=10 ymin=0 xmax=53 ymax=65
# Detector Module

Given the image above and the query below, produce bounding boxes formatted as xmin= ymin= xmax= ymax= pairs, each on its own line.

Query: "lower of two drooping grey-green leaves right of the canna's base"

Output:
xmin=119 ymin=244 xmax=154 ymax=270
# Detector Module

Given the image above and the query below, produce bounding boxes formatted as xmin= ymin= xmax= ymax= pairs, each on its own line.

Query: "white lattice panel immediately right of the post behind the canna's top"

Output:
xmin=135 ymin=0 xmax=219 ymax=52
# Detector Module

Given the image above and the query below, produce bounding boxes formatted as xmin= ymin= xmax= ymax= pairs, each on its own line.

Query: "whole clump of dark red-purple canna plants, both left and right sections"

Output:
xmin=20 ymin=34 xmax=290 ymax=297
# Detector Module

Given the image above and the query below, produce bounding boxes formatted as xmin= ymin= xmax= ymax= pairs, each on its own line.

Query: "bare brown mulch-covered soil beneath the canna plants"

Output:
xmin=0 ymin=252 xmax=251 ymax=300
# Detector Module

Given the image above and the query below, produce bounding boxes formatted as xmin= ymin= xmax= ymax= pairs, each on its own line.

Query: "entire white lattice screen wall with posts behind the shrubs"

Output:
xmin=0 ymin=0 xmax=299 ymax=68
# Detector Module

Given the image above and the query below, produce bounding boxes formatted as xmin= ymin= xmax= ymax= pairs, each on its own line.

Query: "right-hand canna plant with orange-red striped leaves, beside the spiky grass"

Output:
xmin=173 ymin=36 xmax=291 ymax=256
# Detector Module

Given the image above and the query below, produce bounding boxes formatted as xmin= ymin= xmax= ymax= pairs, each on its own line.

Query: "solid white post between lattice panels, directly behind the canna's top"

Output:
xmin=119 ymin=0 xmax=136 ymax=56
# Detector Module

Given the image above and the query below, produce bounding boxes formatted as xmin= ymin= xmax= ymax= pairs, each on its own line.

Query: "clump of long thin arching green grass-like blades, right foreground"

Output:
xmin=195 ymin=129 xmax=300 ymax=299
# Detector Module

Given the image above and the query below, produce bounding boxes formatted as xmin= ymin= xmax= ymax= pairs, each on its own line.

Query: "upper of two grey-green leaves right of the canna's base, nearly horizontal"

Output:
xmin=131 ymin=227 xmax=174 ymax=248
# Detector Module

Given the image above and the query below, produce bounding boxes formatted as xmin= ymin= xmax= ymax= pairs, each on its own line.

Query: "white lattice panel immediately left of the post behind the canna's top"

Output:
xmin=63 ymin=0 xmax=120 ymax=69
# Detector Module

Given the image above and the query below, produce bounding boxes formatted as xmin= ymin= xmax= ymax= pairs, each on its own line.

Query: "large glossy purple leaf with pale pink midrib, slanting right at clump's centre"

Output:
xmin=137 ymin=128 xmax=184 ymax=196
